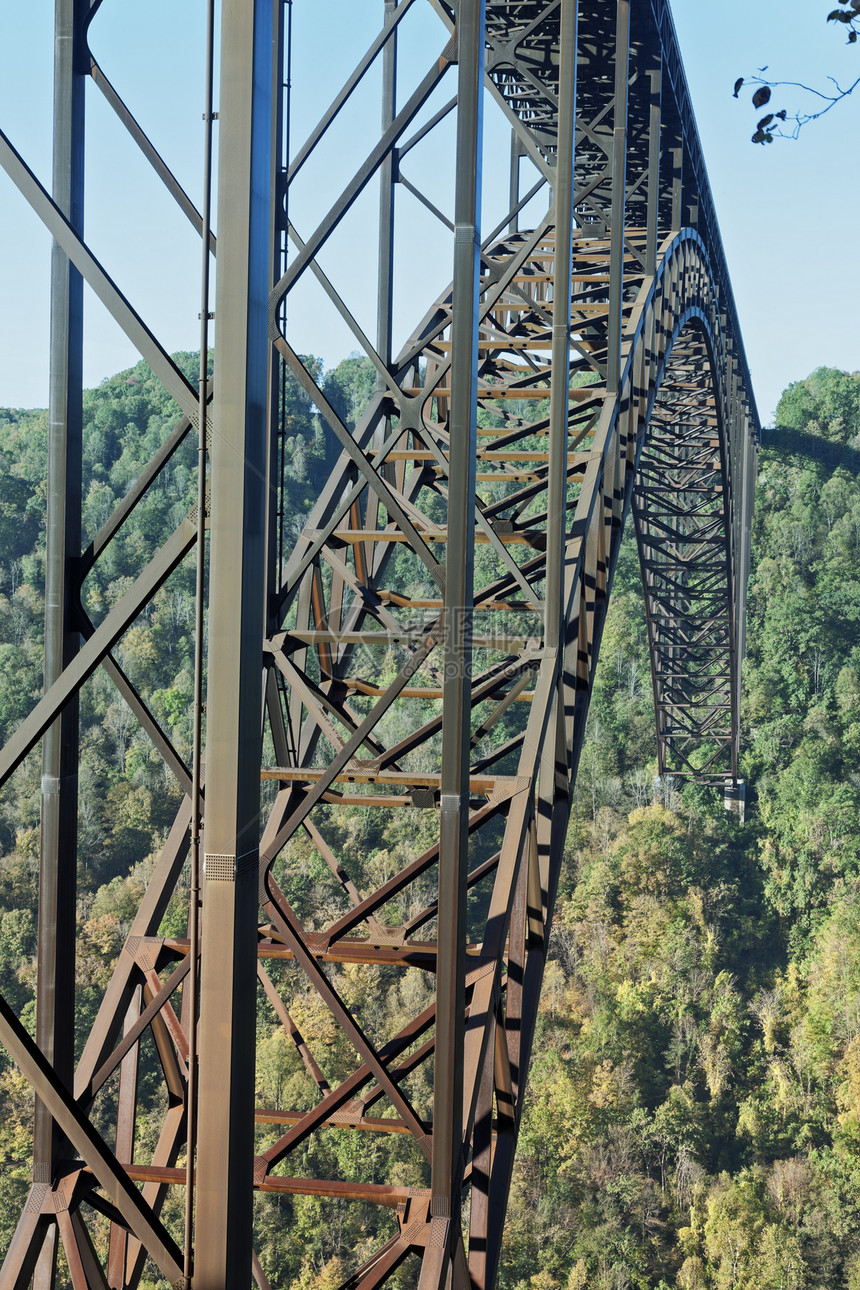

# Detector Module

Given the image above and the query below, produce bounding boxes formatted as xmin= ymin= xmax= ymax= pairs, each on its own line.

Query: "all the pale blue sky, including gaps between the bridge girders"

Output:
xmin=0 ymin=0 xmax=860 ymax=423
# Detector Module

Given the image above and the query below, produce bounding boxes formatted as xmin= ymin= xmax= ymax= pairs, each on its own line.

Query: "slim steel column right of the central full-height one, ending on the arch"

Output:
xmin=544 ymin=0 xmax=578 ymax=645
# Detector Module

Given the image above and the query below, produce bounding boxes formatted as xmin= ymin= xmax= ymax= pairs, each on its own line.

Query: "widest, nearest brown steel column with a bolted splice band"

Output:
xmin=193 ymin=0 xmax=273 ymax=1290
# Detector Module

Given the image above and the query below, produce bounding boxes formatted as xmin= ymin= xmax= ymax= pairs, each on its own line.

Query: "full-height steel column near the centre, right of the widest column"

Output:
xmin=430 ymin=0 xmax=484 ymax=1285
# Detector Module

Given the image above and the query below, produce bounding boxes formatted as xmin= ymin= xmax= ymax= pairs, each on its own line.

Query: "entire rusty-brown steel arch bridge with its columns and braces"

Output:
xmin=0 ymin=0 xmax=758 ymax=1290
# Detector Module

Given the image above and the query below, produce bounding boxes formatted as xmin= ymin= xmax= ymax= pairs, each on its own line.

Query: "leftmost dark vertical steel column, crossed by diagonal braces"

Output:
xmin=34 ymin=0 xmax=89 ymax=1202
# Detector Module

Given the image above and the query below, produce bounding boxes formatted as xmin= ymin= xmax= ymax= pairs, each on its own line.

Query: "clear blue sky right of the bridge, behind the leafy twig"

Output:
xmin=672 ymin=0 xmax=860 ymax=428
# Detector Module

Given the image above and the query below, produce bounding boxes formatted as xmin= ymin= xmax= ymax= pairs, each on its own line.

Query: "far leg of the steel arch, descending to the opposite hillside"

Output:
xmin=621 ymin=230 xmax=756 ymax=786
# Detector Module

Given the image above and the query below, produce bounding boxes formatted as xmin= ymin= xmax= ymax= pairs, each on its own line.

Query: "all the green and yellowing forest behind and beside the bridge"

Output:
xmin=0 ymin=355 xmax=860 ymax=1290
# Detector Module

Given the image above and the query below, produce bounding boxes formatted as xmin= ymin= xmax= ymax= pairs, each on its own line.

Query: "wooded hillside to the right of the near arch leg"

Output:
xmin=505 ymin=369 xmax=860 ymax=1290
